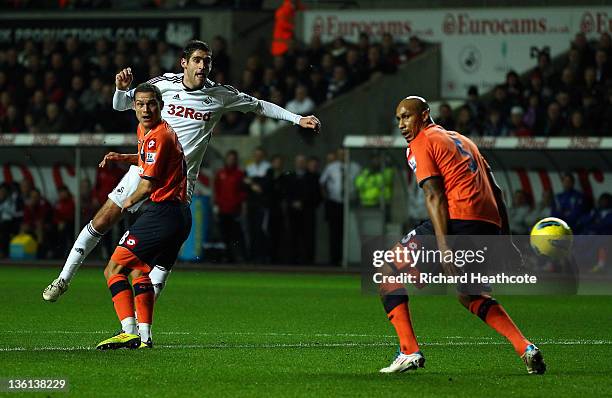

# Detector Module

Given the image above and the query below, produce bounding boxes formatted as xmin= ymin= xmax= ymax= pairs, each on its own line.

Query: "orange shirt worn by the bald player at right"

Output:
xmin=406 ymin=124 xmax=501 ymax=227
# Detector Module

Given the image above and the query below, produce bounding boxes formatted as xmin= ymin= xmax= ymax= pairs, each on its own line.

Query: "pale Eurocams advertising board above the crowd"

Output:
xmin=302 ymin=7 xmax=612 ymax=98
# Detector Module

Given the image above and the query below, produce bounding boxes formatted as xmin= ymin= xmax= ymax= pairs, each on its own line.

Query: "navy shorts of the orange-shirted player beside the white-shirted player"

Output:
xmin=111 ymin=202 xmax=191 ymax=272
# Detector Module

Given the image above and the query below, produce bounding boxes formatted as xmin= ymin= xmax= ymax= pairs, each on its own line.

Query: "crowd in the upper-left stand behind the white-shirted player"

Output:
xmin=0 ymin=34 xmax=424 ymax=136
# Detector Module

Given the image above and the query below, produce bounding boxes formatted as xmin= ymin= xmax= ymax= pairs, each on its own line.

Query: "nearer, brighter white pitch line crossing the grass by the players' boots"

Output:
xmin=0 ymin=340 xmax=612 ymax=352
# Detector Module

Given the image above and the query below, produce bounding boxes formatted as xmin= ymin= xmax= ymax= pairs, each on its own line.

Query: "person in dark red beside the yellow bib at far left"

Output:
xmin=23 ymin=188 xmax=53 ymax=258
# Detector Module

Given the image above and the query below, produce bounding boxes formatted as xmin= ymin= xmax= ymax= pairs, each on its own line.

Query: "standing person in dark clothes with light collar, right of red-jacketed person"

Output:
xmin=244 ymin=147 xmax=271 ymax=263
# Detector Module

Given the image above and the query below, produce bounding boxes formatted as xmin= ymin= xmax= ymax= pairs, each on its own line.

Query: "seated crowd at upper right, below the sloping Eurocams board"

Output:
xmin=436 ymin=32 xmax=612 ymax=137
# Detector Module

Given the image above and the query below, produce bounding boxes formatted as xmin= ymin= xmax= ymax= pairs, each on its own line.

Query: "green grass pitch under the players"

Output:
xmin=0 ymin=266 xmax=612 ymax=397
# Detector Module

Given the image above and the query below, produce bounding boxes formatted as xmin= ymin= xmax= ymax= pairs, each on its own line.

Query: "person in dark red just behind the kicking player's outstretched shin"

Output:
xmin=53 ymin=186 xmax=75 ymax=258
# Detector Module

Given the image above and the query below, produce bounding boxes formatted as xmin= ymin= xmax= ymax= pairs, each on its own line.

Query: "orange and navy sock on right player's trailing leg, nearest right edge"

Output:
xmin=469 ymin=296 xmax=531 ymax=356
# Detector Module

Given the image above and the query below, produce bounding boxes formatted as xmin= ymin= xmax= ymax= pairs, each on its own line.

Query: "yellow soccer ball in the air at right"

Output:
xmin=529 ymin=217 xmax=574 ymax=260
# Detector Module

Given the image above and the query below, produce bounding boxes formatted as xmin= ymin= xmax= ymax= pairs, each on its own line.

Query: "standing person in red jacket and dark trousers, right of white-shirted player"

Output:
xmin=214 ymin=149 xmax=246 ymax=263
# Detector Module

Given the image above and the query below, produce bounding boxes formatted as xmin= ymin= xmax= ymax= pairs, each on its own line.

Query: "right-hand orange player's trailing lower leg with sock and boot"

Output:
xmin=459 ymin=294 xmax=546 ymax=374
